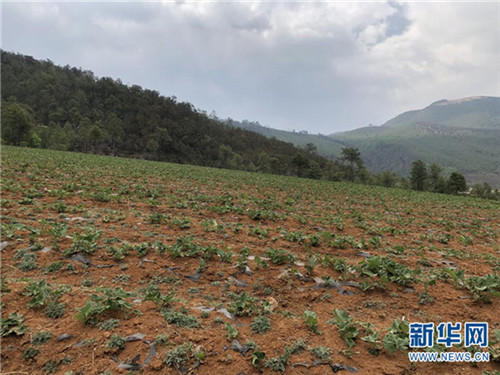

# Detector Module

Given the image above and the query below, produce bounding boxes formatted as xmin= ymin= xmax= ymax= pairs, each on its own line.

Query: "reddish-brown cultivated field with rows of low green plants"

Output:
xmin=1 ymin=147 xmax=500 ymax=375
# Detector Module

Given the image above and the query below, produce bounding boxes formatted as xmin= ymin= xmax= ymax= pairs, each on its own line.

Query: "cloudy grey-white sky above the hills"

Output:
xmin=2 ymin=1 xmax=500 ymax=134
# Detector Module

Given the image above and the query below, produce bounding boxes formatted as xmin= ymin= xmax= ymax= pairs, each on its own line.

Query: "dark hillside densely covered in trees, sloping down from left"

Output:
xmin=1 ymin=51 xmax=332 ymax=178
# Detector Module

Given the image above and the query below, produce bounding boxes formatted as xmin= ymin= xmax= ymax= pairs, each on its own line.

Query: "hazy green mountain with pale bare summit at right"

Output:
xmin=331 ymin=96 xmax=500 ymax=187
